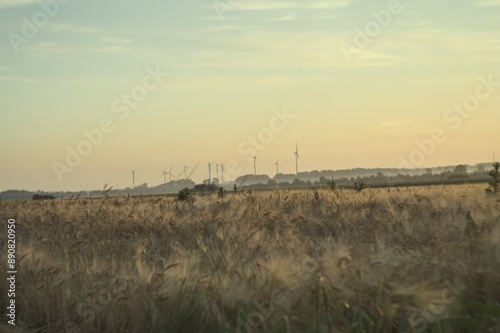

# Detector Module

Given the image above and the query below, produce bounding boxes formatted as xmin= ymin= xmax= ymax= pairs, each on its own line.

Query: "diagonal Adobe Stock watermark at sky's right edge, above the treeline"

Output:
xmin=398 ymin=74 xmax=500 ymax=169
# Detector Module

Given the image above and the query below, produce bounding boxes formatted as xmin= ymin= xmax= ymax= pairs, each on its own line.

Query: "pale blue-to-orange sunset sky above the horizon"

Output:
xmin=0 ymin=0 xmax=500 ymax=191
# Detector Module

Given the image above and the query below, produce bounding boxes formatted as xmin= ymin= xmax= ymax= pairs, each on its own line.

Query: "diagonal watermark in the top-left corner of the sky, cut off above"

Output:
xmin=7 ymin=0 xmax=71 ymax=54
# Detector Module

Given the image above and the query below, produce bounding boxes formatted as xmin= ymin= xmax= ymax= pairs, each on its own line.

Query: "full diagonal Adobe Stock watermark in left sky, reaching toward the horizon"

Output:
xmin=52 ymin=66 xmax=168 ymax=182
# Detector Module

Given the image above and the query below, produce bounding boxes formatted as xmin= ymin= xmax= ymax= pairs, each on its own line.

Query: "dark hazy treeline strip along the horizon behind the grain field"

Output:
xmin=0 ymin=163 xmax=492 ymax=200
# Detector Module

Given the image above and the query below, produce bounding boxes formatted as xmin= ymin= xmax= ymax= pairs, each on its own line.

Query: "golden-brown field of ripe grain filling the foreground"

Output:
xmin=0 ymin=184 xmax=500 ymax=333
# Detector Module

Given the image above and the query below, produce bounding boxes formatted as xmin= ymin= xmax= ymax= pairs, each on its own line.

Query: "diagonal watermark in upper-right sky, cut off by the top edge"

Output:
xmin=340 ymin=0 xmax=403 ymax=64
